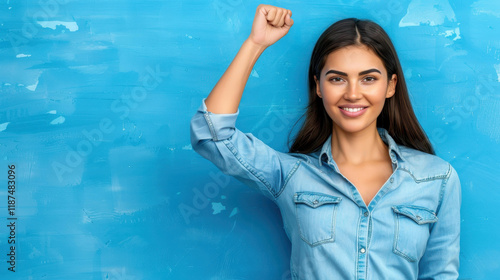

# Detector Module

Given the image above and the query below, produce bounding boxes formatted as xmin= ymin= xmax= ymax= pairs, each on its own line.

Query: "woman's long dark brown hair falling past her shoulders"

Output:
xmin=289 ymin=18 xmax=434 ymax=154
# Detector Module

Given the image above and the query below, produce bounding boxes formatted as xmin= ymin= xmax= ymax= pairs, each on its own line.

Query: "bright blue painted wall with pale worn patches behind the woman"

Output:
xmin=0 ymin=0 xmax=500 ymax=280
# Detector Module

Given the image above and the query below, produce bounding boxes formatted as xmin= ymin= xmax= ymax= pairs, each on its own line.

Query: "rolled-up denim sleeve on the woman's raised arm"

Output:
xmin=191 ymin=99 xmax=292 ymax=201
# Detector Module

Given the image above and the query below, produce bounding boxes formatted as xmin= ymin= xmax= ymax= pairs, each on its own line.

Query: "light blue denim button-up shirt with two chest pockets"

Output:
xmin=191 ymin=101 xmax=461 ymax=279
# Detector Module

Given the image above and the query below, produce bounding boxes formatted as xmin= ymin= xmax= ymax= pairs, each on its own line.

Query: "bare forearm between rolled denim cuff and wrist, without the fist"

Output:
xmin=205 ymin=39 xmax=265 ymax=114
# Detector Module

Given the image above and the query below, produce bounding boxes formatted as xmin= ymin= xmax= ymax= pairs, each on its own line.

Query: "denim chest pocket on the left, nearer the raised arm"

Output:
xmin=293 ymin=192 xmax=342 ymax=246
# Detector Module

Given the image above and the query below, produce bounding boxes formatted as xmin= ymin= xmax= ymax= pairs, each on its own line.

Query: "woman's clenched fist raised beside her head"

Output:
xmin=249 ymin=5 xmax=293 ymax=47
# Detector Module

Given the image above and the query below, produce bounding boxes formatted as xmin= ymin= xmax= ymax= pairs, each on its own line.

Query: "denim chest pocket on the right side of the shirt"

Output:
xmin=392 ymin=205 xmax=438 ymax=262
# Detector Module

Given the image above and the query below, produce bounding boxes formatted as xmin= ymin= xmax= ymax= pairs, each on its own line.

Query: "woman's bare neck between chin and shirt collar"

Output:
xmin=332 ymin=125 xmax=389 ymax=165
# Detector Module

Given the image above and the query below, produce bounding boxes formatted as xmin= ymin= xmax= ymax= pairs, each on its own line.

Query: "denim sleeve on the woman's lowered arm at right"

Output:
xmin=418 ymin=166 xmax=462 ymax=279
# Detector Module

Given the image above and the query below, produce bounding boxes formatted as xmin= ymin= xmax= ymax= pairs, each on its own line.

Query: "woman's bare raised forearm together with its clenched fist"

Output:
xmin=205 ymin=5 xmax=293 ymax=114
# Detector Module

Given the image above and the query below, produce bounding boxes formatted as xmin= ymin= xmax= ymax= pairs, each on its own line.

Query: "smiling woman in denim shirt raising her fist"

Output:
xmin=191 ymin=5 xmax=461 ymax=279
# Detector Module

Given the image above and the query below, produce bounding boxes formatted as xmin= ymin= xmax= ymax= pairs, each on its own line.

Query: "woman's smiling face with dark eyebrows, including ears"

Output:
xmin=315 ymin=46 xmax=397 ymax=133
